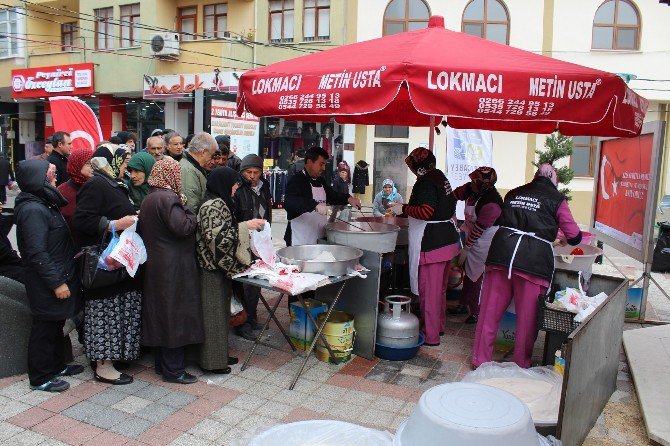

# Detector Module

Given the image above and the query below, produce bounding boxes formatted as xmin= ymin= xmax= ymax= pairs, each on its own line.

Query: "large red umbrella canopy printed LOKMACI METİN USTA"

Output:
xmin=237 ymin=16 xmax=648 ymax=136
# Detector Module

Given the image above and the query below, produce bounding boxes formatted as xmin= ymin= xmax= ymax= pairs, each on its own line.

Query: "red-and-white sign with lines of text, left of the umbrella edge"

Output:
xmin=210 ymin=99 xmax=260 ymax=158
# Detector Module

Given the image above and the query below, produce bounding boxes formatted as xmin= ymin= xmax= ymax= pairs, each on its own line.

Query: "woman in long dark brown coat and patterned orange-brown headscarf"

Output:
xmin=140 ymin=155 xmax=204 ymax=384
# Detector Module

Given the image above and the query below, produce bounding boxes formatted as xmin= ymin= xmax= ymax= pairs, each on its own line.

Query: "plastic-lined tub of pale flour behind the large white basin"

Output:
xmin=461 ymin=362 xmax=563 ymax=425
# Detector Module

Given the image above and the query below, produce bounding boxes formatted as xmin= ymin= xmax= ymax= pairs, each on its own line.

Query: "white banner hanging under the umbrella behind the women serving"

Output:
xmin=446 ymin=127 xmax=493 ymax=220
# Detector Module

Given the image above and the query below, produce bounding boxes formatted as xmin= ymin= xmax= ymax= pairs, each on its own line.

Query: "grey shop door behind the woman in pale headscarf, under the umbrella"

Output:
xmin=372 ymin=142 xmax=409 ymax=202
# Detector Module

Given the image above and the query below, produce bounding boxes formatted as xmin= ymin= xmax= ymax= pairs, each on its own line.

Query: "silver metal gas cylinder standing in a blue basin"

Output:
xmin=377 ymin=295 xmax=419 ymax=348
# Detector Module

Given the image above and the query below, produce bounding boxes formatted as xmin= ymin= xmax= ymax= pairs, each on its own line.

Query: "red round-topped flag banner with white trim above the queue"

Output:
xmin=49 ymin=96 xmax=102 ymax=150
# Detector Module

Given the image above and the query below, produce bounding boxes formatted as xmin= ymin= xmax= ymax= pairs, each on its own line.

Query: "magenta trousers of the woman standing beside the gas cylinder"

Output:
xmin=419 ymin=262 xmax=449 ymax=344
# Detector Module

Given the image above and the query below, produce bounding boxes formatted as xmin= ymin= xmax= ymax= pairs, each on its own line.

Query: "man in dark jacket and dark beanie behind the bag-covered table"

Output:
xmin=234 ymin=155 xmax=272 ymax=341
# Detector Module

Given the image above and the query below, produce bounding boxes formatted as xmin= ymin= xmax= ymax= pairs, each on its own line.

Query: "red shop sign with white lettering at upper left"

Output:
xmin=12 ymin=63 xmax=95 ymax=99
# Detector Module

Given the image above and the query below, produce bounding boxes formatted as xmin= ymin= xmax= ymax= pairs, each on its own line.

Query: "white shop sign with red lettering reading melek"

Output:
xmin=142 ymin=69 xmax=242 ymax=99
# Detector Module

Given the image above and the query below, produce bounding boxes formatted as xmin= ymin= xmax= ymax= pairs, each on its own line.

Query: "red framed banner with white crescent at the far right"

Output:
xmin=594 ymin=134 xmax=654 ymax=250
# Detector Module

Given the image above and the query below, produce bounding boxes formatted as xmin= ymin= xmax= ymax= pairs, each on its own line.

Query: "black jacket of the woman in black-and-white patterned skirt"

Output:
xmin=72 ymin=172 xmax=142 ymax=299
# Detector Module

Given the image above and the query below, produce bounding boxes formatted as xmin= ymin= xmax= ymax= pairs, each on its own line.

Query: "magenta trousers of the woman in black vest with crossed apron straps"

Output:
xmin=472 ymin=268 xmax=546 ymax=368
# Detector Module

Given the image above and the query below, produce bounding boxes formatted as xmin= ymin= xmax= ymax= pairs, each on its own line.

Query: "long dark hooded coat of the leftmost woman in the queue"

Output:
xmin=14 ymin=159 xmax=80 ymax=320
